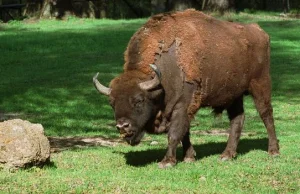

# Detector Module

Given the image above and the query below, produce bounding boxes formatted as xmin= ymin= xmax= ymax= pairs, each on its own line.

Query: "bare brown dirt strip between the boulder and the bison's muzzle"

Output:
xmin=48 ymin=136 xmax=123 ymax=153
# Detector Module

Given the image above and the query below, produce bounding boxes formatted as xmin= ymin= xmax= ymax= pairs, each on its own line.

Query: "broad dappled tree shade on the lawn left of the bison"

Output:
xmin=0 ymin=24 xmax=136 ymax=137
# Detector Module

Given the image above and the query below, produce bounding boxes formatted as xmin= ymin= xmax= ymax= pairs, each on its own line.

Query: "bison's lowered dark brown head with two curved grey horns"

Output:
xmin=93 ymin=65 xmax=163 ymax=145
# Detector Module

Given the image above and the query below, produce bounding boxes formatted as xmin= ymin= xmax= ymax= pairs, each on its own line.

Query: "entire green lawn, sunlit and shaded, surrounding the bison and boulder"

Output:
xmin=0 ymin=13 xmax=300 ymax=193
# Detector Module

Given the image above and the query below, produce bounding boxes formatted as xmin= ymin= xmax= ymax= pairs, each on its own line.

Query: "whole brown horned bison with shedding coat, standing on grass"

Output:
xmin=93 ymin=10 xmax=279 ymax=168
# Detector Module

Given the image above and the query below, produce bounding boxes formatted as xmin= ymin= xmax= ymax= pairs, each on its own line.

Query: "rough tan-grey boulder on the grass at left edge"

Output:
xmin=0 ymin=119 xmax=50 ymax=168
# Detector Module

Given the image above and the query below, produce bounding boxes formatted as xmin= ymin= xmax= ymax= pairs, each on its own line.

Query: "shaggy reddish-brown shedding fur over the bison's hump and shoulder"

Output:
xmin=124 ymin=10 xmax=206 ymax=81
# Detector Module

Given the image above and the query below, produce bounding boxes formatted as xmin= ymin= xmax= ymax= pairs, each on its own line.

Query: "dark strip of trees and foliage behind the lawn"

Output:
xmin=0 ymin=0 xmax=300 ymax=21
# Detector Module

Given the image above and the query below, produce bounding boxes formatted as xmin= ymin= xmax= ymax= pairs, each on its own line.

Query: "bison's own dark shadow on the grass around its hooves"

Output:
xmin=123 ymin=138 xmax=268 ymax=167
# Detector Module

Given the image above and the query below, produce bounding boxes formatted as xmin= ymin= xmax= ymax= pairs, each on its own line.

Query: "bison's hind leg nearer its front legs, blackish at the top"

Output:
xmin=221 ymin=95 xmax=245 ymax=160
